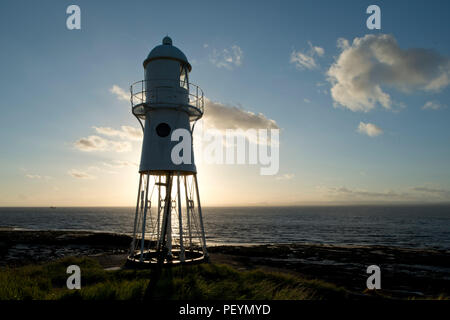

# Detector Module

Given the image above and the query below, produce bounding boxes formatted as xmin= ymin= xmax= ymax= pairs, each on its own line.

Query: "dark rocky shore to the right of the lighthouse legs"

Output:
xmin=210 ymin=244 xmax=450 ymax=298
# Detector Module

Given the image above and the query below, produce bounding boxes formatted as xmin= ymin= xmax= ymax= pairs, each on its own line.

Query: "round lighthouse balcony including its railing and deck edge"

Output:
xmin=130 ymin=79 xmax=204 ymax=121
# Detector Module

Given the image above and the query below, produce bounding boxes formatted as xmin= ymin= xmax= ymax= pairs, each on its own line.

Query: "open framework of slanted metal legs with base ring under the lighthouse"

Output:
xmin=127 ymin=172 xmax=209 ymax=268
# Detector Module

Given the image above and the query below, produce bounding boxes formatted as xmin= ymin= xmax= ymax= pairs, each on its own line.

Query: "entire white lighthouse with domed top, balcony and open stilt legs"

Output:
xmin=127 ymin=37 xmax=208 ymax=266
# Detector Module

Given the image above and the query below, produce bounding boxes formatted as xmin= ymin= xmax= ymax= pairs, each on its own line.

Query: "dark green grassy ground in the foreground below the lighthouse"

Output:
xmin=0 ymin=258 xmax=347 ymax=300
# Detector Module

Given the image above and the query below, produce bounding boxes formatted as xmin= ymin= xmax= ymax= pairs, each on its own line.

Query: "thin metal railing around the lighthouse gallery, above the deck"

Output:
xmin=130 ymin=79 xmax=204 ymax=116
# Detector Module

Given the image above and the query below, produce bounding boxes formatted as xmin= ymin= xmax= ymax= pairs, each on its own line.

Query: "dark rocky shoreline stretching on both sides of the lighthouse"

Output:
xmin=0 ymin=228 xmax=450 ymax=298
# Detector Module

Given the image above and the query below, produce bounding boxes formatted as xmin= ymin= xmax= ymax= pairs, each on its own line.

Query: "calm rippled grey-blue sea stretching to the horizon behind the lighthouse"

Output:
xmin=0 ymin=205 xmax=450 ymax=249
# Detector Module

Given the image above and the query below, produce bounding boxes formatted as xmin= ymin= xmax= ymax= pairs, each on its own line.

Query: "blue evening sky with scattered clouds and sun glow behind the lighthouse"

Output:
xmin=0 ymin=0 xmax=450 ymax=206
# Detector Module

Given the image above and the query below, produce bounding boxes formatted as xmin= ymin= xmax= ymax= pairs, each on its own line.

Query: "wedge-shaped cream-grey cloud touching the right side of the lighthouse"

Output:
xmin=203 ymin=99 xmax=279 ymax=130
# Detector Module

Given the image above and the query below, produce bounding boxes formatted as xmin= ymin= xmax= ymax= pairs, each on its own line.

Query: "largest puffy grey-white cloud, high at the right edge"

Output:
xmin=327 ymin=34 xmax=450 ymax=112
